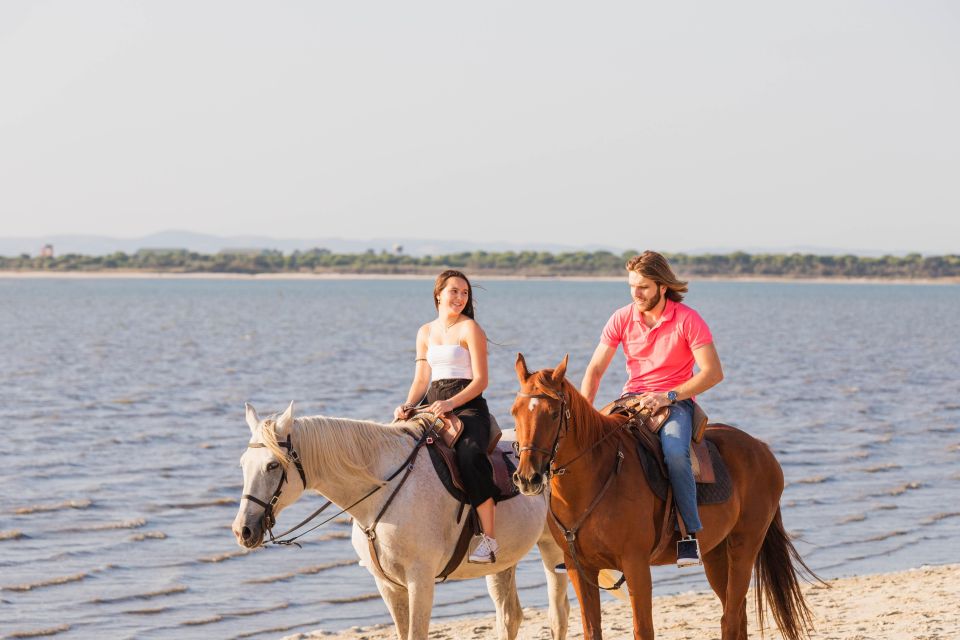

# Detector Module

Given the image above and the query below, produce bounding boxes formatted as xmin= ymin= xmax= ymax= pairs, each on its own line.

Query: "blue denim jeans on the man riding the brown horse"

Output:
xmin=660 ymin=400 xmax=703 ymax=533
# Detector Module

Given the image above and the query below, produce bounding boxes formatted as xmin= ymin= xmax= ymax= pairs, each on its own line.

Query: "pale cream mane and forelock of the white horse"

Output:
xmin=262 ymin=416 xmax=423 ymax=485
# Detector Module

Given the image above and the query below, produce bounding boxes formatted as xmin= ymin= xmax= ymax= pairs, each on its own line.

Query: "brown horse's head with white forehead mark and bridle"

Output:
xmin=510 ymin=353 xmax=570 ymax=495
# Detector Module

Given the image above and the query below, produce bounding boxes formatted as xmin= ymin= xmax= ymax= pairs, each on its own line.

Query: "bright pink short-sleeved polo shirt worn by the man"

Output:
xmin=600 ymin=300 xmax=713 ymax=393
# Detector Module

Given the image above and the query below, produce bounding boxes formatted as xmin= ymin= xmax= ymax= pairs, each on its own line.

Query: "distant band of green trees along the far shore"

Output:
xmin=0 ymin=249 xmax=960 ymax=279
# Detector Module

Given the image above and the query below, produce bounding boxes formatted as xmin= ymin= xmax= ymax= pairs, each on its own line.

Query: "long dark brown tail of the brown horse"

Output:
xmin=754 ymin=507 xmax=823 ymax=640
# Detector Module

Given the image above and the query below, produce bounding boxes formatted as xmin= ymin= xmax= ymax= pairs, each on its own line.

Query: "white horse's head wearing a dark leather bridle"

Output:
xmin=233 ymin=402 xmax=305 ymax=548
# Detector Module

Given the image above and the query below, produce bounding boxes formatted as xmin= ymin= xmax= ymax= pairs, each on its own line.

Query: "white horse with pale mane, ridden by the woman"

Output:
xmin=233 ymin=403 xmax=570 ymax=640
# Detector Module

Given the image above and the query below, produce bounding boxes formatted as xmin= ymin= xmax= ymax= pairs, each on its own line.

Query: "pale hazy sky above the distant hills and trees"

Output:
xmin=0 ymin=0 xmax=960 ymax=253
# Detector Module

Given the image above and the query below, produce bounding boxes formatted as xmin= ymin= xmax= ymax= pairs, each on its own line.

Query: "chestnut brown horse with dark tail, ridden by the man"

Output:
xmin=512 ymin=354 xmax=815 ymax=640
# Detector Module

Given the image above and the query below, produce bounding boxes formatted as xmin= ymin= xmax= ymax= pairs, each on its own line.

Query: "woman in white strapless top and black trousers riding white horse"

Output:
xmin=393 ymin=269 xmax=499 ymax=563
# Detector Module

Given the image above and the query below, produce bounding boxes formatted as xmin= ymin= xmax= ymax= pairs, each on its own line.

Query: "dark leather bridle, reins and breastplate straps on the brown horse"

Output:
xmin=517 ymin=384 xmax=631 ymax=591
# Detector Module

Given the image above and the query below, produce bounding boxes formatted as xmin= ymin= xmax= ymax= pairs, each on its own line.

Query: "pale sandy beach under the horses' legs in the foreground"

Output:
xmin=284 ymin=564 xmax=960 ymax=640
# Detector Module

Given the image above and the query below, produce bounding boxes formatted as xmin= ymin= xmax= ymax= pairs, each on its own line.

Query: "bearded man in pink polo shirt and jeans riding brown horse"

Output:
xmin=580 ymin=251 xmax=723 ymax=567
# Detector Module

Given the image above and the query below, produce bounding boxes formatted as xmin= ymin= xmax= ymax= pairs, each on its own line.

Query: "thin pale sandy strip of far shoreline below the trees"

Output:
xmin=0 ymin=270 xmax=960 ymax=285
